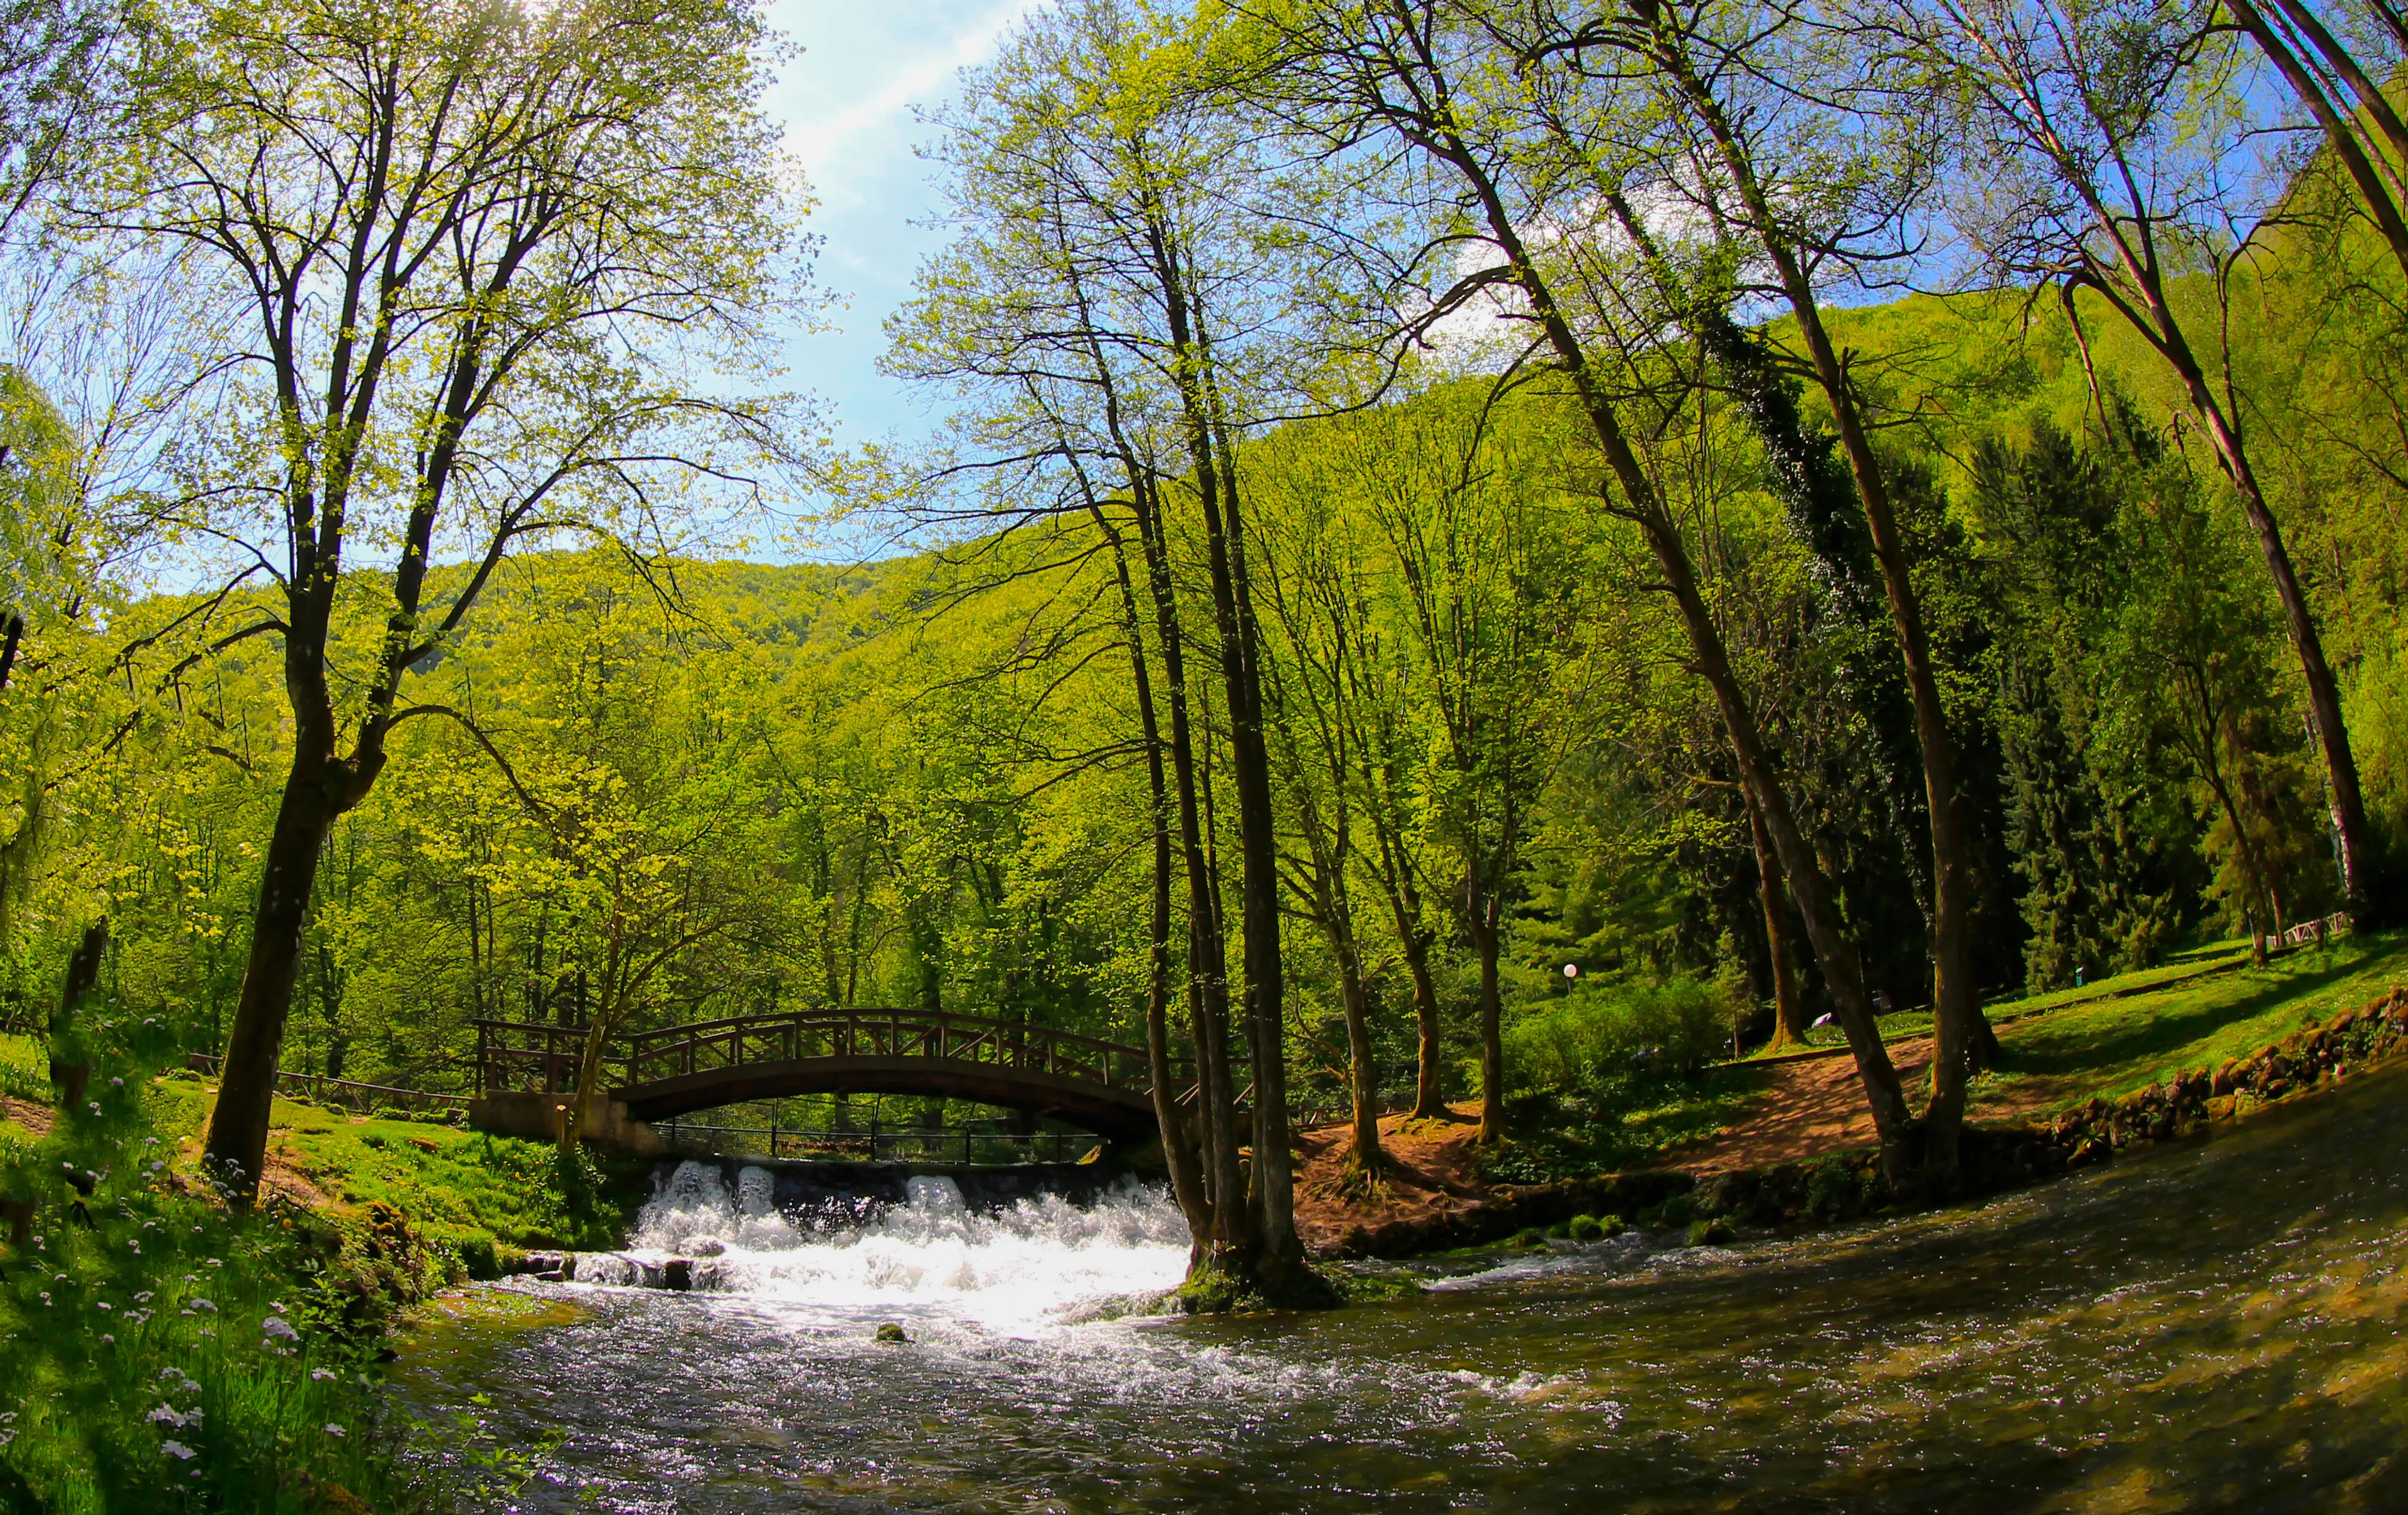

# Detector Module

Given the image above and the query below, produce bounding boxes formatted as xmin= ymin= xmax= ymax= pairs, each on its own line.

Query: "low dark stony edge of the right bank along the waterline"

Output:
xmin=1324 ymin=963 xmax=2408 ymax=1260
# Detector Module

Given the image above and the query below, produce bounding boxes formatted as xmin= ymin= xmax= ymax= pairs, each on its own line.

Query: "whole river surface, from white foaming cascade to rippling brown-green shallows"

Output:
xmin=399 ymin=1067 xmax=2408 ymax=1515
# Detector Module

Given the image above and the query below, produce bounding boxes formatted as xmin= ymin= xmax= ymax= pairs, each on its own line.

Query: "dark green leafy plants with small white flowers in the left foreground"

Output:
xmin=0 ymin=1007 xmax=433 ymax=1515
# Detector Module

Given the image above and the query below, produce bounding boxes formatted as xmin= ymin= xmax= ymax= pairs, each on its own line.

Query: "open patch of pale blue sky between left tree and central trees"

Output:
xmin=766 ymin=0 xmax=1040 ymax=446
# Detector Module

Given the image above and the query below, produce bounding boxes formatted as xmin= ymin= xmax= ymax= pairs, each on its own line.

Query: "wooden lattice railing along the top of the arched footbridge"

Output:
xmin=472 ymin=1009 xmax=1195 ymax=1096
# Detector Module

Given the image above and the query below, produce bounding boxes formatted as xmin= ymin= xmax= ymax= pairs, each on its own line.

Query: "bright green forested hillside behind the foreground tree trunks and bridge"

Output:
xmin=8 ymin=272 xmax=2408 ymax=1125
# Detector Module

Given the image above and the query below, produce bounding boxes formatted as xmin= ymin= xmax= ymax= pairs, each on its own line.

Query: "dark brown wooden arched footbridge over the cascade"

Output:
xmin=474 ymin=1009 xmax=1195 ymax=1142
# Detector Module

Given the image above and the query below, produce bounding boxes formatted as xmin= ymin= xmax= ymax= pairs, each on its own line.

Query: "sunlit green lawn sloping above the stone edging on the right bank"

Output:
xmin=1975 ymin=932 xmax=2408 ymax=1113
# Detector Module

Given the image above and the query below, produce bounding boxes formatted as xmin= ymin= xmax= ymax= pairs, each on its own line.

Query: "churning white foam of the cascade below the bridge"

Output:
xmin=616 ymin=1163 xmax=1187 ymax=1332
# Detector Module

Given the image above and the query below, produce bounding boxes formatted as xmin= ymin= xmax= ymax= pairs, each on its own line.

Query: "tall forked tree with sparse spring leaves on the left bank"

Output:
xmin=60 ymin=0 xmax=790 ymax=1195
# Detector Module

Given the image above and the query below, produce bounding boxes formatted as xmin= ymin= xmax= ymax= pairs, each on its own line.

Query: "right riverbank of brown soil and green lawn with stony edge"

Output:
xmin=1298 ymin=932 xmax=2408 ymax=1257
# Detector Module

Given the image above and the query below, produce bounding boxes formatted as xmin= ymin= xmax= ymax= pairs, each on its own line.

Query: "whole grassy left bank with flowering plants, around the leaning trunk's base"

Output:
xmin=0 ymin=1009 xmax=655 ymax=1515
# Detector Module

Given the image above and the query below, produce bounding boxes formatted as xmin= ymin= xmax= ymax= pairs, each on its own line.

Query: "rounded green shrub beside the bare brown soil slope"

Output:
xmin=1505 ymin=978 xmax=1731 ymax=1091
